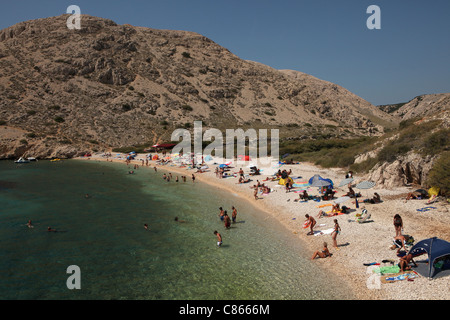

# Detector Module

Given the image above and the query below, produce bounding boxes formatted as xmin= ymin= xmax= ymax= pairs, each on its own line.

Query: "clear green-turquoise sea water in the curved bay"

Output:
xmin=0 ymin=160 xmax=352 ymax=300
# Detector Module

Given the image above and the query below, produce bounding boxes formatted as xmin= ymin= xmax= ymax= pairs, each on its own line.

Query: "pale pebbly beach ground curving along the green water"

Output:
xmin=78 ymin=153 xmax=450 ymax=300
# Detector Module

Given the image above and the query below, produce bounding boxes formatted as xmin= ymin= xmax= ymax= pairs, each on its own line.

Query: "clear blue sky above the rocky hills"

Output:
xmin=0 ymin=0 xmax=450 ymax=105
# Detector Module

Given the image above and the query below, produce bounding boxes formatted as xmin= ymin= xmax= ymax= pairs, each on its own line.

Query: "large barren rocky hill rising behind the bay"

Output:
xmin=0 ymin=15 xmax=396 ymax=158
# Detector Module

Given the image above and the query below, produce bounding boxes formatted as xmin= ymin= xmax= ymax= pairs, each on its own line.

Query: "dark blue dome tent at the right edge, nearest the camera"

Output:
xmin=409 ymin=237 xmax=450 ymax=278
